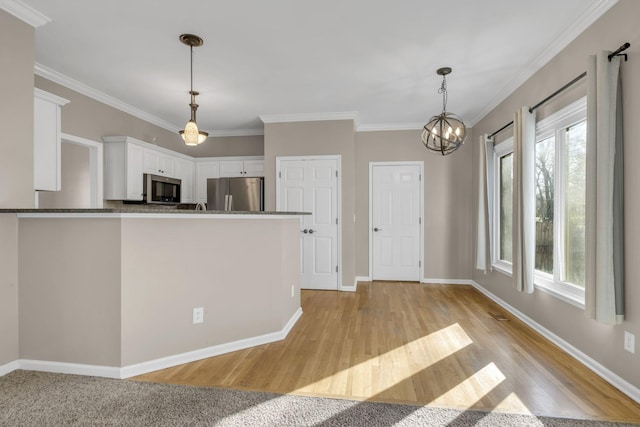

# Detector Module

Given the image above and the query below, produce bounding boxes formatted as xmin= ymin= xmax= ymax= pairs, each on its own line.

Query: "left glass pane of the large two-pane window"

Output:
xmin=535 ymin=137 xmax=555 ymax=274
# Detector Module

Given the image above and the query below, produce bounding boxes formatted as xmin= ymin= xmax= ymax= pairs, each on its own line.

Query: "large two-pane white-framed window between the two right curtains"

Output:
xmin=534 ymin=98 xmax=587 ymax=305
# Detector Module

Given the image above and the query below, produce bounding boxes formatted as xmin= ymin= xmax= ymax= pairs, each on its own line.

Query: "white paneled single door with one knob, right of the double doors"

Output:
xmin=369 ymin=166 xmax=422 ymax=281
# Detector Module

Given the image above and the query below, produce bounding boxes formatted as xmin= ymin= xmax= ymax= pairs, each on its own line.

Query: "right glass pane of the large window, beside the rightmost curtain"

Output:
xmin=563 ymin=122 xmax=587 ymax=287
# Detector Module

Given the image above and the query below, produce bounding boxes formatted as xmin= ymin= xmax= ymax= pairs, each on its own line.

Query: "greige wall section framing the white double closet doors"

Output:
xmin=264 ymin=120 xmax=355 ymax=286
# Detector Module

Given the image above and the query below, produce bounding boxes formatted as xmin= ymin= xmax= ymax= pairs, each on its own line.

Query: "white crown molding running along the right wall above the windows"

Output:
xmin=469 ymin=0 xmax=618 ymax=127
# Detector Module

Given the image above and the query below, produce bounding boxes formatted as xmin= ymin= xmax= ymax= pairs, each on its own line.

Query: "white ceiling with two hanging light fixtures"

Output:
xmin=11 ymin=0 xmax=617 ymax=135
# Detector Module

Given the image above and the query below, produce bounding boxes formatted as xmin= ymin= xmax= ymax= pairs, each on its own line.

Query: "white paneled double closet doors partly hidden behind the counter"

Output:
xmin=277 ymin=158 xmax=339 ymax=290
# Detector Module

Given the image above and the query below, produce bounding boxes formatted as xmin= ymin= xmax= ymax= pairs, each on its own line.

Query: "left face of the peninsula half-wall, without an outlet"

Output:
xmin=19 ymin=221 xmax=121 ymax=366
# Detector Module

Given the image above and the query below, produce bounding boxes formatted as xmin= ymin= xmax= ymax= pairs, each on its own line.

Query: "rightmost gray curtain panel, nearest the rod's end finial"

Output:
xmin=585 ymin=51 xmax=624 ymax=324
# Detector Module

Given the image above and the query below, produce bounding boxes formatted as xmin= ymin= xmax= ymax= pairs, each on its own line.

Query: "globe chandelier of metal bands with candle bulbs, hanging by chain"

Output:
xmin=422 ymin=67 xmax=467 ymax=156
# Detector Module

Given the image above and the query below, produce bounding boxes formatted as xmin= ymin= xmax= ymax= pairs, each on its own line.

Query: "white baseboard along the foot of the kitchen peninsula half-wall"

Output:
xmin=0 ymin=307 xmax=302 ymax=379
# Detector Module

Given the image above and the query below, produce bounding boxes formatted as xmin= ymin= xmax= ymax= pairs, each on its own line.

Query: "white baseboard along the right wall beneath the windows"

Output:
xmin=469 ymin=280 xmax=640 ymax=403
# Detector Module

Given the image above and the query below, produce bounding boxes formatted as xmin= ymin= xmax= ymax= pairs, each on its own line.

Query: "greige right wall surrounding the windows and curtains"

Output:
xmin=469 ymin=0 xmax=640 ymax=387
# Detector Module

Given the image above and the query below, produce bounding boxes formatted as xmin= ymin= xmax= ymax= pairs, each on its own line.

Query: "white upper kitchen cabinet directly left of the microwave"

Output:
xmin=102 ymin=137 xmax=144 ymax=200
